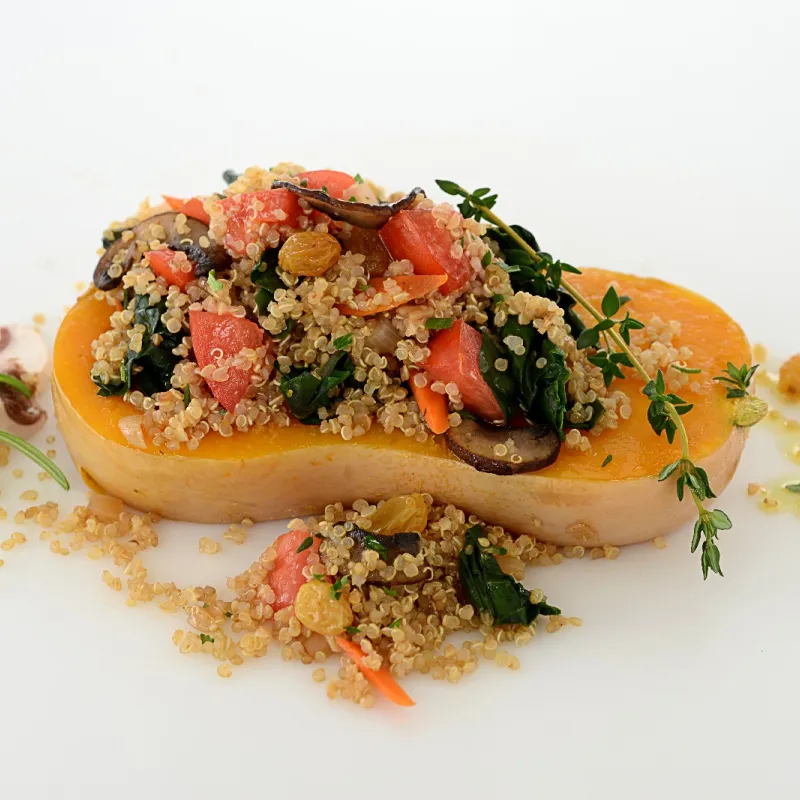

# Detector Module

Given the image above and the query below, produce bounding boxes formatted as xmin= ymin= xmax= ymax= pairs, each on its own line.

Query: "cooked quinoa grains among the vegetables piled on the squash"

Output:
xmin=86 ymin=163 xmax=692 ymax=456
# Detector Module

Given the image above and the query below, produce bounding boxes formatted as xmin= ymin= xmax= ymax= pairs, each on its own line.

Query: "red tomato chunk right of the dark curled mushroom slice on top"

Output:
xmin=380 ymin=209 xmax=472 ymax=294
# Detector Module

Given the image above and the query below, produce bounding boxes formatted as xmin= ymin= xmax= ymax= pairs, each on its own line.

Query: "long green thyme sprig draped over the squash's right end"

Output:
xmin=436 ymin=181 xmax=744 ymax=579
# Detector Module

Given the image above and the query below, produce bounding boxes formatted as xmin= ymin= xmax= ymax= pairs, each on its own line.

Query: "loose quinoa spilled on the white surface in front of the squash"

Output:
xmin=28 ymin=494 xmax=592 ymax=708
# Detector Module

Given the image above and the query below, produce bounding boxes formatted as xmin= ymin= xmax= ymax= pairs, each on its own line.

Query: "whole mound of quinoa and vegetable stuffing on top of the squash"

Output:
xmin=91 ymin=163 xmax=692 ymax=462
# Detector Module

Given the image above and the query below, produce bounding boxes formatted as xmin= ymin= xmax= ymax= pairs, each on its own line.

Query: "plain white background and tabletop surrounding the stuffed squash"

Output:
xmin=0 ymin=0 xmax=800 ymax=798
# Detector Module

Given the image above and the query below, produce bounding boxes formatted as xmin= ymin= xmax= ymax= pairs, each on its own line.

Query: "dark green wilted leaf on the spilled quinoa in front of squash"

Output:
xmin=458 ymin=525 xmax=561 ymax=625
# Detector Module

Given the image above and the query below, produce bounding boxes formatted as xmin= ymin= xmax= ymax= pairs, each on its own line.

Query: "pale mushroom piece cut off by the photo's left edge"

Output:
xmin=0 ymin=325 xmax=49 ymax=438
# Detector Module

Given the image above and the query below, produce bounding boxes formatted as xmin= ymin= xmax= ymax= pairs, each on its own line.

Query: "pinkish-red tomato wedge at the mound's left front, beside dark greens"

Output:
xmin=189 ymin=311 xmax=264 ymax=414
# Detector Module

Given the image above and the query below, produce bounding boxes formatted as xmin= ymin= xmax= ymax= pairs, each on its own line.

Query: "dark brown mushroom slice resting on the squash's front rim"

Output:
xmin=445 ymin=419 xmax=561 ymax=475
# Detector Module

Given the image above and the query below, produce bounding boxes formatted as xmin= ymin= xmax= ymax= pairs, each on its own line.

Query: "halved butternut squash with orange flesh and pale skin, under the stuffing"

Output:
xmin=53 ymin=269 xmax=751 ymax=544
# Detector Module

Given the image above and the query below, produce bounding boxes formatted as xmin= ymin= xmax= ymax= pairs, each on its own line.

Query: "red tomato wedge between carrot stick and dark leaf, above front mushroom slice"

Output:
xmin=423 ymin=319 xmax=503 ymax=422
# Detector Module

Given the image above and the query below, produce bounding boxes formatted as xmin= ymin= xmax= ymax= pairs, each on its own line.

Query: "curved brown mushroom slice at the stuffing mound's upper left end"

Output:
xmin=94 ymin=211 xmax=231 ymax=291
